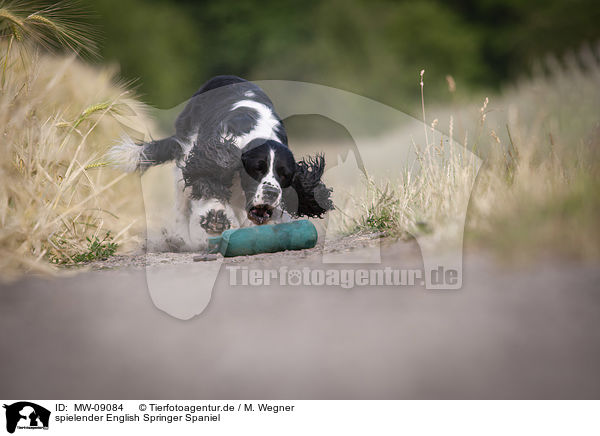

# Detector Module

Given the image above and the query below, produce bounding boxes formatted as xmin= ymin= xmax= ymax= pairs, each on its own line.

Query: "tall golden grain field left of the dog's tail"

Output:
xmin=0 ymin=41 xmax=146 ymax=278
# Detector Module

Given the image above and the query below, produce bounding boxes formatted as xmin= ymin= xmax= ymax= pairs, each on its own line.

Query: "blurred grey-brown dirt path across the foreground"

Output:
xmin=0 ymin=236 xmax=600 ymax=399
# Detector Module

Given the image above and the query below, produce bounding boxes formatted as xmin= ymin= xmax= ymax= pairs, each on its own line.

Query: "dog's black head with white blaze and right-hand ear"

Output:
xmin=241 ymin=139 xmax=333 ymax=225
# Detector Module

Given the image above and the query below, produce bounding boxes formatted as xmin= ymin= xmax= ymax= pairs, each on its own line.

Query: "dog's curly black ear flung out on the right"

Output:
xmin=284 ymin=154 xmax=333 ymax=218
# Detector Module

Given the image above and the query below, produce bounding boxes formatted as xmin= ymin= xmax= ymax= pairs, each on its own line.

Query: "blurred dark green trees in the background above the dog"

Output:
xmin=90 ymin=0 xmax=600 ymax=110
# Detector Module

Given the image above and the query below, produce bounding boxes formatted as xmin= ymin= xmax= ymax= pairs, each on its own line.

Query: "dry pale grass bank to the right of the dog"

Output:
xmin=346 ymin=48 xmax=600 ymax=259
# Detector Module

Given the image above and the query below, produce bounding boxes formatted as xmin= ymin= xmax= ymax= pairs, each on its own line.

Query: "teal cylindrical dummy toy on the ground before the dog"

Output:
xmin=208 ymin=220 xmax=317 ymax=257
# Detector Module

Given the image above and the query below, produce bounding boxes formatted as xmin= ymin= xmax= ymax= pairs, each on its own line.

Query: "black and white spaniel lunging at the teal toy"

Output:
xmin=108 ymin=76 xmax=333 ymax=250
